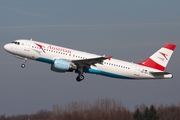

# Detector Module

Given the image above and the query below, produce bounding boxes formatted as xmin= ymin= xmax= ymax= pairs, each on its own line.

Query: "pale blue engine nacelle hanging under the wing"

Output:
xmin=51 ymin=59 xmax=77 ymax=72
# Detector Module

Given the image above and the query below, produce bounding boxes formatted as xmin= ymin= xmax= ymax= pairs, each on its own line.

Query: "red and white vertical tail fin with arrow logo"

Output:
xmin=139 ymin=44 xmax=176 ymax=71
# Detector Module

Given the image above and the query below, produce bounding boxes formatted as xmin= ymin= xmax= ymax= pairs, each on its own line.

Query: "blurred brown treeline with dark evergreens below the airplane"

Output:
xmin=0 ymin=98 xmax=180 ymax=120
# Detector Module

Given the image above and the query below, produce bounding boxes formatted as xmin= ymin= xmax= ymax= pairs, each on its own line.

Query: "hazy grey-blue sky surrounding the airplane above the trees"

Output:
xmin=0 ymin=0 xmax=180 ymax=115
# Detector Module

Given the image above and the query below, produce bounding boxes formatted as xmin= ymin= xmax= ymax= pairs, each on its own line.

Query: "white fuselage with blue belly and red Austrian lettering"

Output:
xmin=4 ymin=40 xmax=172 ymax=79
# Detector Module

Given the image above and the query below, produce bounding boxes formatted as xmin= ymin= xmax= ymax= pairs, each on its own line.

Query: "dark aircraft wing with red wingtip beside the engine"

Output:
xmin=72 ymin=56 xmax=112 ymax=68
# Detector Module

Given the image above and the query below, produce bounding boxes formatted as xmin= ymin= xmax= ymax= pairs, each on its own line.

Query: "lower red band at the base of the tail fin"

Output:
xmin=138 ymin=58 xmax=165 ymax=71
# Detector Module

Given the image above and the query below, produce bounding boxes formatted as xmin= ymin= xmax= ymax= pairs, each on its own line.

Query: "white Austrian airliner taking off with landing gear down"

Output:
xmin=4 ymin=39 xmax=176 ymax=82
